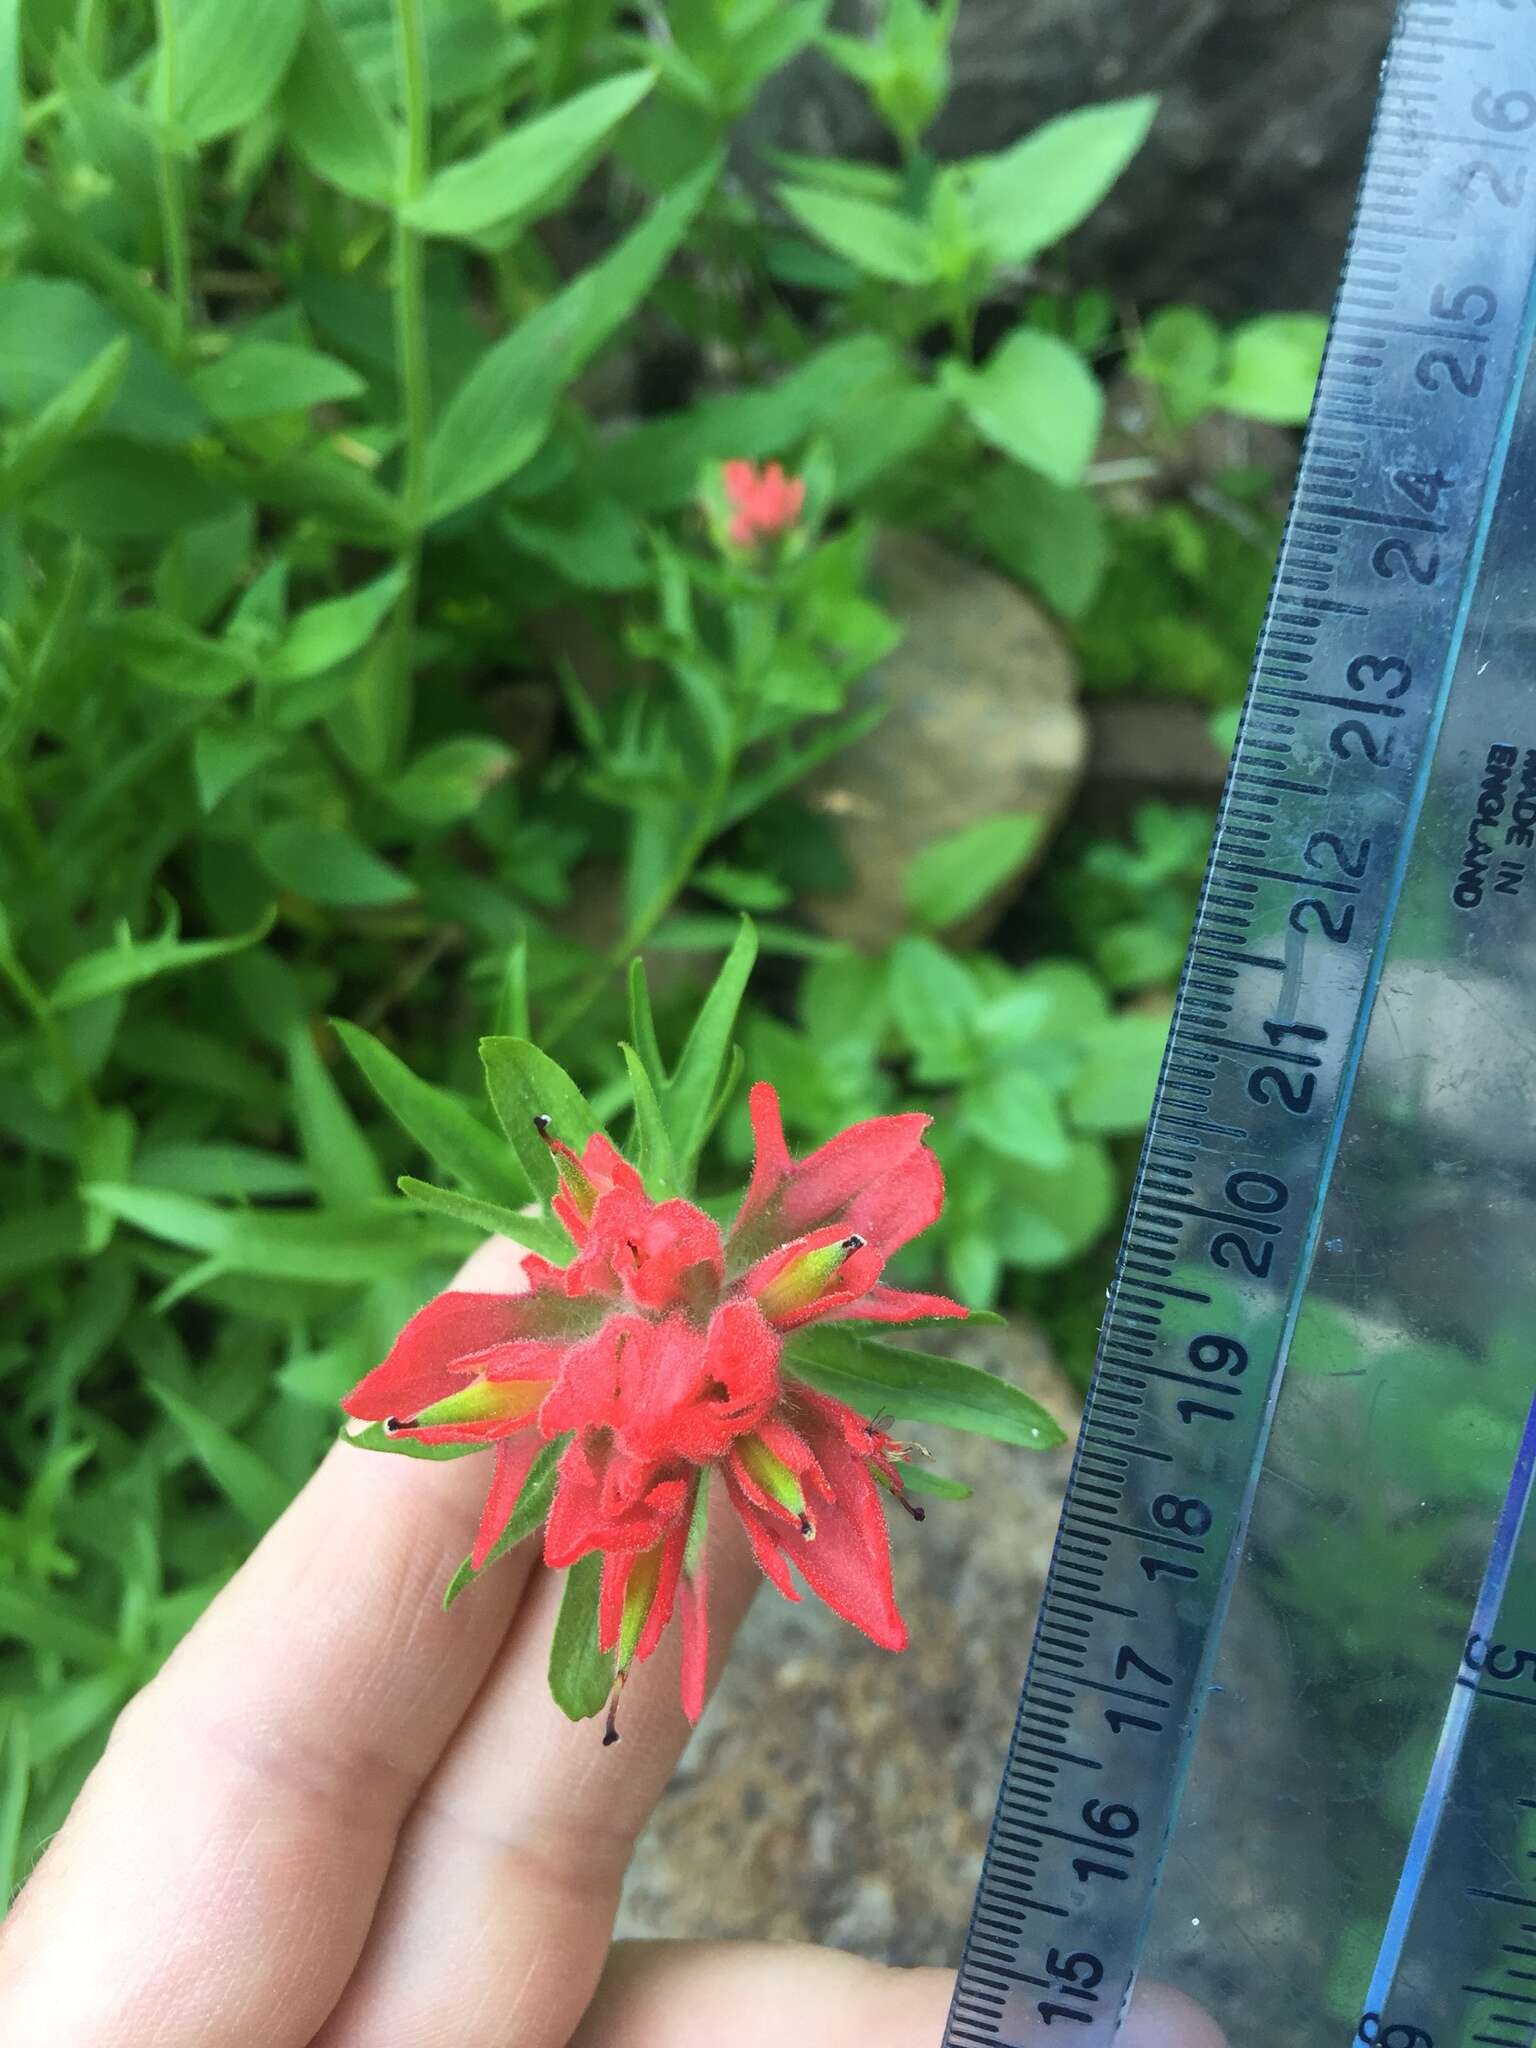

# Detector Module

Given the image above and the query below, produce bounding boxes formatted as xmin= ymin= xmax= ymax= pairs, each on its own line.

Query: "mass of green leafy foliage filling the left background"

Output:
xmin=0 ymin=0 xmax=1327 ymax=1880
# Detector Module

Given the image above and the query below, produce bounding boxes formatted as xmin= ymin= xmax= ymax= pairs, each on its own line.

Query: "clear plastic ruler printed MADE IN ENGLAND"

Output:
xmin=944 ymin=0 xmax=1536 ymax=2048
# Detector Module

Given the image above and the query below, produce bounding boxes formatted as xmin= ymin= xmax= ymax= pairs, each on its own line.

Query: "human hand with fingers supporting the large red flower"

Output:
xmin=0 ymin=1239 xmax=1221 ymax=2048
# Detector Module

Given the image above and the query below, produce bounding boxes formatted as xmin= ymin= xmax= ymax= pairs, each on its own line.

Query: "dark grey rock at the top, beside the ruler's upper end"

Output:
xmin=743 ymin=0 xmax=1393 ymax=313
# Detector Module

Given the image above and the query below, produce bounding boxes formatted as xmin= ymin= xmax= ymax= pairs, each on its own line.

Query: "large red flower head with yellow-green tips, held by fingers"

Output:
xmin=344 ymin=1083 xmax=965 ymax=1733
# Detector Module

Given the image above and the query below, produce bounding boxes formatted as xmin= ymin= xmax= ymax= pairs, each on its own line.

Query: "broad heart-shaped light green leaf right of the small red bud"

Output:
xmin=942 ymin=328 xmax=1104 ymax=495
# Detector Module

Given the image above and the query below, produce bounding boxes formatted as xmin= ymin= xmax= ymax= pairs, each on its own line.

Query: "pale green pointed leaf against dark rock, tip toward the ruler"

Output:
xmin=967 ymin=94 xmax=1157 ymax=264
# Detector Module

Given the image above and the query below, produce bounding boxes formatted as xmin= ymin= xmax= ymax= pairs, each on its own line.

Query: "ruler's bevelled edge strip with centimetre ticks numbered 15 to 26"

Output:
xmin=944 ymin=0 xmax=1536 ymax=2048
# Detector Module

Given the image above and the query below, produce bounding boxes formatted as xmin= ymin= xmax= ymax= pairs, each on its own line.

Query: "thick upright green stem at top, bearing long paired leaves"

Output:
xmin=391 ymin=0 xmax=432 ymax=770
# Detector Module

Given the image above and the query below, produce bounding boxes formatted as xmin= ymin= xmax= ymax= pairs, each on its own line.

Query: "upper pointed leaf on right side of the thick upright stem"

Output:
xmin=403 ymin=72 xmax=655 ymax=236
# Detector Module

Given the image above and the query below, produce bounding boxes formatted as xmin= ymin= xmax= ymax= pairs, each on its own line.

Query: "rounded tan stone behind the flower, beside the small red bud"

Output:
xmin=807 ymin=535 xmax=1087 ymax=948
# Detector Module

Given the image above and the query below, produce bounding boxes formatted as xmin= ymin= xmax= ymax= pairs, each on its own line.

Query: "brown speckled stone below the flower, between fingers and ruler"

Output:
xmin=621 ymin=1329 xmax=1075 ymax=1964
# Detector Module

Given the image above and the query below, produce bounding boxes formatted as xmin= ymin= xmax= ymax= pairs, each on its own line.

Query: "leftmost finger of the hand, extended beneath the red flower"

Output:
xmin=0 ymin=1239 xmax=548 ymax=2048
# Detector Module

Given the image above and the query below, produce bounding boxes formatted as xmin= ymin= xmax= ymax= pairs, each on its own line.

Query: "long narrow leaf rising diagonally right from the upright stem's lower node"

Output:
xmin=428 ymin=158 xmax=719 ymax=520
